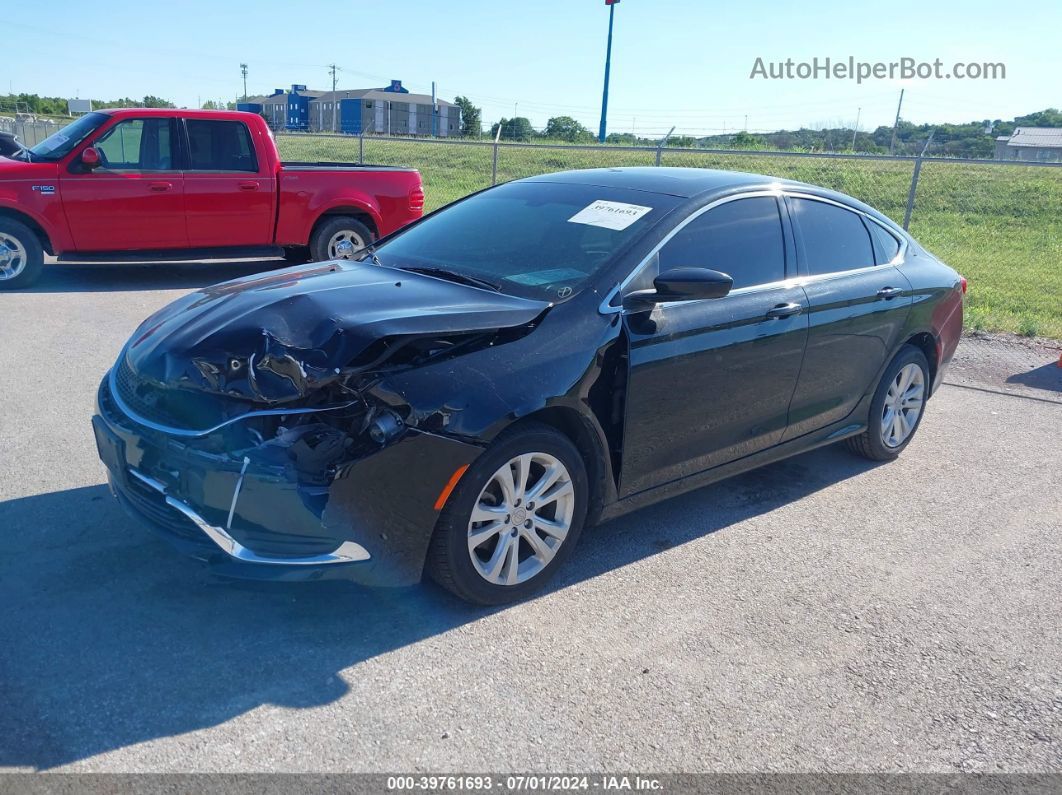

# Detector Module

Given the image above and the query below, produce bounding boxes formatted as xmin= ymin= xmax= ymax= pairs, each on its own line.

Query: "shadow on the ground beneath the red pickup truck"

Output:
xmin=18 ymin=258 xmax=290 ymax=293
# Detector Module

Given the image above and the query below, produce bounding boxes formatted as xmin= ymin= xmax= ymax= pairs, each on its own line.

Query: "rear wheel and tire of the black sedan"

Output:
xmin=844 ymin=345 xmax=929 ymax=461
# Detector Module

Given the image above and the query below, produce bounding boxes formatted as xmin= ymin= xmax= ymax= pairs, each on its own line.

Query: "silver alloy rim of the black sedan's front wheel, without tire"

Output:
xmin=468 ymin=452 xmax=576 ymax=586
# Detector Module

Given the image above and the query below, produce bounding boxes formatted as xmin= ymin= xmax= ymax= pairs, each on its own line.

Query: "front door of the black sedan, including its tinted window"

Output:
xmin=620 ymin=196 xmax=808 ymax=497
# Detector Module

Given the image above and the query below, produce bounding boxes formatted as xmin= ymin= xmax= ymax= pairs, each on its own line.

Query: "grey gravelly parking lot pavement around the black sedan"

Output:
xmin=0 ymin=263 xmax=1062 ymax=772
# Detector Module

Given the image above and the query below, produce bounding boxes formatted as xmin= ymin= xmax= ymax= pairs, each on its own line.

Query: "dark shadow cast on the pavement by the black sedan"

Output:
xmin=0 ymin=448 xmax=874 ymax=770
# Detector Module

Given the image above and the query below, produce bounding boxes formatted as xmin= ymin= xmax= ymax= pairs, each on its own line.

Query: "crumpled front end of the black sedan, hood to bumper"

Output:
xmin=92 ymin=262 xmax=541 ymax=585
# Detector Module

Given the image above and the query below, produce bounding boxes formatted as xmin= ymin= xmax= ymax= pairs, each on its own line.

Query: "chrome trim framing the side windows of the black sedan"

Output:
xmin=598 ymin=188 xmax=909 ymax=315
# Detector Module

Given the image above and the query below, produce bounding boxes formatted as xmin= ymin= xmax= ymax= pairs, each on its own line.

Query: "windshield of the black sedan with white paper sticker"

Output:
xmin=369 ymin=183 xmax=680 ymax=301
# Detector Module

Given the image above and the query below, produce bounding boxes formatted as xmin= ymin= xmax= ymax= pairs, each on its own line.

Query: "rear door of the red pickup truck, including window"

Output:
xmin=184 ymin=118 xmax=276 ymax=248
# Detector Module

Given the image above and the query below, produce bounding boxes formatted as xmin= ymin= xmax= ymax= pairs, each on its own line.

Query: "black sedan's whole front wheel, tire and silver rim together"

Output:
xmin=426 ymin=422 xmax=588 ymax=605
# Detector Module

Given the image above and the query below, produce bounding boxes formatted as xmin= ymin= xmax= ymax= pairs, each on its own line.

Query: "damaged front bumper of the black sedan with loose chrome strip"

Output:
xmin=92 ymin=378 xmax=480 ymax=585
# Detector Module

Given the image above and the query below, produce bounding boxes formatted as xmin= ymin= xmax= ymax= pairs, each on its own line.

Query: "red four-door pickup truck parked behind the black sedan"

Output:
xmin=0 ymin=108 xmax=424 ymax=289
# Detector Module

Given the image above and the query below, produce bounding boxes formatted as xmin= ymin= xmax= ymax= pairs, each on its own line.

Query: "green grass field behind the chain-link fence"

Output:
xmin=277 ymin=135 xmax=1062 ymax=339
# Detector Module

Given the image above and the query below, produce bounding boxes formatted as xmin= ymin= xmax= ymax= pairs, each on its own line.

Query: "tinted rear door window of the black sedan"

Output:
xmin=790 ymin=198 xmax=874 ymax=276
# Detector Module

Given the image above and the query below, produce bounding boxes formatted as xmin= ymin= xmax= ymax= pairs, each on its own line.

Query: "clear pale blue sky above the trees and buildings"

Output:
xmin=8 ymin=0 xmax=1062 ymax=136
